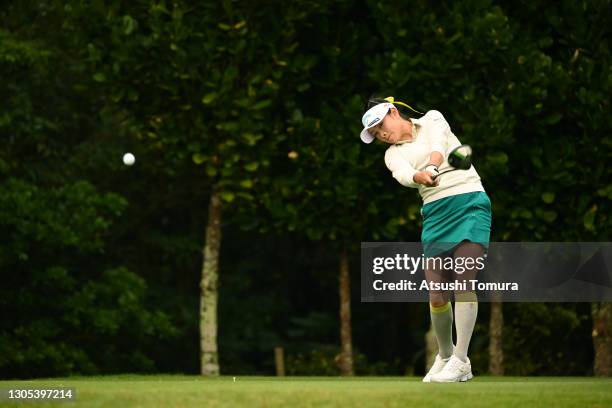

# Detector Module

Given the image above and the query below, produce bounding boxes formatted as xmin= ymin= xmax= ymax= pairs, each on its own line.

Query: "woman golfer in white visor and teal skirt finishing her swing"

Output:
xmin=360 ymin=97 xmax=491 ymax=382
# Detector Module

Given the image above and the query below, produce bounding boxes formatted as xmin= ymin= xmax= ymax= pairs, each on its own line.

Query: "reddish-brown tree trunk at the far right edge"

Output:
xmin=591 ymin=302 xmax=612 ymax=377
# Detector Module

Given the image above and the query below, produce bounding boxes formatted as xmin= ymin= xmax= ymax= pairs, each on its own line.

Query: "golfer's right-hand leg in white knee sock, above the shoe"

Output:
xmin=453 ymin=242 xmax=484 ymax=362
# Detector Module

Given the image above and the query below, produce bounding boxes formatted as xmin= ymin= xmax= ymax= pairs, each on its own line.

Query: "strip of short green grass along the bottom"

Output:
xmin=0 ymin=375 xmax=612 ymax=408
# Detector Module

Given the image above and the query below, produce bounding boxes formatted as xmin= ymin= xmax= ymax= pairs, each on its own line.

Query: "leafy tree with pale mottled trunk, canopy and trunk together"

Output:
xmin=60 ymin=1 xmax=330 ymax=375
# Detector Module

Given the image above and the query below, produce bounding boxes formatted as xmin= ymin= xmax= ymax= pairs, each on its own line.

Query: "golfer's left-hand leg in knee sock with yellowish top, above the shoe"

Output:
xmin=425 ymin=262 xmax=453 ymax=359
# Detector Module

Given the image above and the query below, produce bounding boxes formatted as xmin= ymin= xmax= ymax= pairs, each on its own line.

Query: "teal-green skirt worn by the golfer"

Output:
xmin=421 ymin=191 xmax=491 ymax=257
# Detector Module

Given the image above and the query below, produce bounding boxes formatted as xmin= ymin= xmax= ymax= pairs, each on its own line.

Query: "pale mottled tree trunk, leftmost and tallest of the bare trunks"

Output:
xmin=200 ymin=188 xmax=221 ymax=375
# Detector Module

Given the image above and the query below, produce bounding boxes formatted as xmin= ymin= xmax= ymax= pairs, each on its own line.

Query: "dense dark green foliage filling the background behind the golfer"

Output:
xmin=0 ymin=0 xmax=612 ymax=377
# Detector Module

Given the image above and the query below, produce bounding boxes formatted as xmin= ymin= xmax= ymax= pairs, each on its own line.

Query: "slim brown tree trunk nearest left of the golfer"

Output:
xmin=338 ymin=249 xmax=355 ymax=376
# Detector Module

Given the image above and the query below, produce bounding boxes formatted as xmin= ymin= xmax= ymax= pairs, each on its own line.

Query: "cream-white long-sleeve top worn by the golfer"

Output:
xmin=385 ymin=110 xmax=484 ymax=204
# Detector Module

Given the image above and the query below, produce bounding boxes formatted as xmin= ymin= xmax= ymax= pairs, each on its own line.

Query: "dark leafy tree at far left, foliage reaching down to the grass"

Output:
xmin=0 ymin=11 xmax=174 ymax=377
